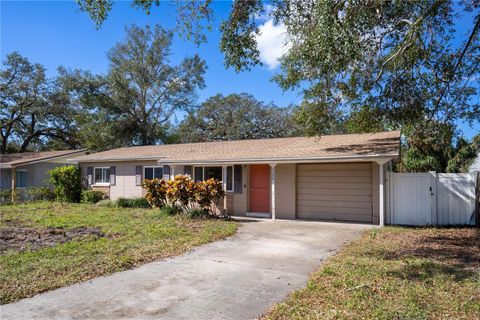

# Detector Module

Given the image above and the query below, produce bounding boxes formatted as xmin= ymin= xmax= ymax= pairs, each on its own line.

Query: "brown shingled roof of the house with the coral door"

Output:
xmin=69 ymin=131 xmax=400 ymax=164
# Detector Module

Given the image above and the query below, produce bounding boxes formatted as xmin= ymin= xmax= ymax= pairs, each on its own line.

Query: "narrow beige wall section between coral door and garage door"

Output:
xmin=275 ymin=164 xmax=296 ymax=219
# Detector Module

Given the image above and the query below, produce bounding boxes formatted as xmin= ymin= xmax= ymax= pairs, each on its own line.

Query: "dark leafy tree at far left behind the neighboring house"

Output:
xmin=0 ymin=52 xmax=77 ymax=154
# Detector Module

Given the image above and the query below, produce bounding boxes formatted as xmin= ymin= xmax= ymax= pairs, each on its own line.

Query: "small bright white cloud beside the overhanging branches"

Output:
xmin=257 ymin=19 xmax=290 ymax=70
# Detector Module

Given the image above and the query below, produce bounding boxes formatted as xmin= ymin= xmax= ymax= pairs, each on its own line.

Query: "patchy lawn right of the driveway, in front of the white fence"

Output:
xmin=264 ymin=227 xmax=480 ymax=319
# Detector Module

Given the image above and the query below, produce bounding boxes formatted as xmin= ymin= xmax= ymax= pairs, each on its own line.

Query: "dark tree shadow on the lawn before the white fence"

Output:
xmin=384 ymin=229 xmax=480 ymax=281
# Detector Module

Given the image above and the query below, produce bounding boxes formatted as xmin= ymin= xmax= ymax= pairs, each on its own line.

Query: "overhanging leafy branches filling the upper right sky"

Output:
xmin=79 ymin=0 xmax=480 ymax=134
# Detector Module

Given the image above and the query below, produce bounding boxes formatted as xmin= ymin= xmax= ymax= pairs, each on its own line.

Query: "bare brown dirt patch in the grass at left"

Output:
xmin=0 ymin=226 xmax=105 ymax=254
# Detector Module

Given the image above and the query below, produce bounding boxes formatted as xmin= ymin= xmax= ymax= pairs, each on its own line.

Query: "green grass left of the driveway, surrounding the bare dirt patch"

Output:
xmin=0 ymin=202 xmax=237 ymax=304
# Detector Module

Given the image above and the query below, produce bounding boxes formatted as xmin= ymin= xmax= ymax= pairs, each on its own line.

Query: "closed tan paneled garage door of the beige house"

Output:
xmin=297 ymin=163 xmax=373 ymax=223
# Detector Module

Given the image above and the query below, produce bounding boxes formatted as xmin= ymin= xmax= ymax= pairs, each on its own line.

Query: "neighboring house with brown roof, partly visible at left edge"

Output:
xmin=0 ymin=150 xmax=88 ymax=189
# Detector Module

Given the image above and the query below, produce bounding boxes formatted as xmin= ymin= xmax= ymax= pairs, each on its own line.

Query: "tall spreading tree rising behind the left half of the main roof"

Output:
xmin=60 ymin=26 xmax=206 ymax=149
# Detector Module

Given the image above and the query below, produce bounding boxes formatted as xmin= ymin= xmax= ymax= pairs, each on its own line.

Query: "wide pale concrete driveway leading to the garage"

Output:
xmin=0 ymin=220 xmax=371 ymax=320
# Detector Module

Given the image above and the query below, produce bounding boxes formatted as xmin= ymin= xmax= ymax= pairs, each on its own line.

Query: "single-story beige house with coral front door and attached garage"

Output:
xmin=69 ymin=131 xmax=400 ymax=225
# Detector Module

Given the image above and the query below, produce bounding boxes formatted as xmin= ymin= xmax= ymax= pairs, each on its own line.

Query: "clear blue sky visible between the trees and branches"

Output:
xmin=0 ymin=0 xmax=479 ymax=137
